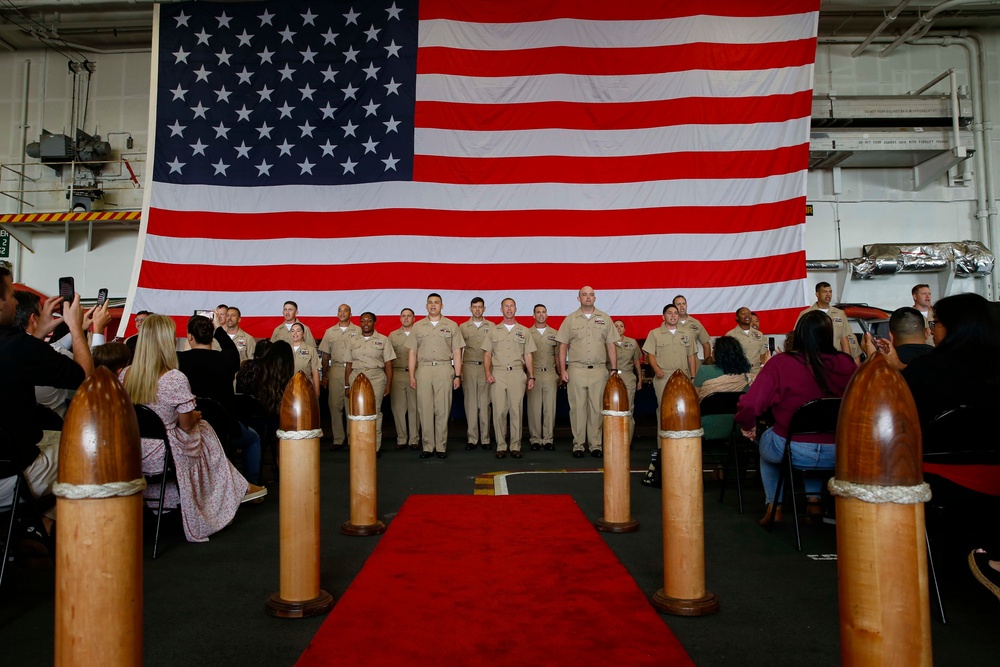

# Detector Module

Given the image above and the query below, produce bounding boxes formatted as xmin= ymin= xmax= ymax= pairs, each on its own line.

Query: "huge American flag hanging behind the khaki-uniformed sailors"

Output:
xmin=129 ymin=0 xmax=819 ymax=337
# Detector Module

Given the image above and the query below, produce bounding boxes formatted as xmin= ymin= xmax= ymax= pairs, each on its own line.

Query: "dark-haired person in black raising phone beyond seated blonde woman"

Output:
xmin=177 ymin=315 xmax=260 ymax=484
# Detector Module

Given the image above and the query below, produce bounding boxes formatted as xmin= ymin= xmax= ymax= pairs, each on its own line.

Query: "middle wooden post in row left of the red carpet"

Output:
xmin=266 ymin=371 xmax=333 ymax=618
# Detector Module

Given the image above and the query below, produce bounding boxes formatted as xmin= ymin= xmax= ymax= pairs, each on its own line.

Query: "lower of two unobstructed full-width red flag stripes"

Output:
xmin=139 ymin=252 xmax=806 ymax=292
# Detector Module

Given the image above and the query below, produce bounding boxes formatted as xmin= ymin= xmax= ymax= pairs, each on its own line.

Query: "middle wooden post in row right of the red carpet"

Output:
xmin=652 ymin=371 xmax=719 ymax=616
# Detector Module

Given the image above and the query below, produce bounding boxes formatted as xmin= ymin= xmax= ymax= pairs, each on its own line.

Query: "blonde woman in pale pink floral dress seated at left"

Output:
xmin=119 ymin=315 xmax=267 ymax=542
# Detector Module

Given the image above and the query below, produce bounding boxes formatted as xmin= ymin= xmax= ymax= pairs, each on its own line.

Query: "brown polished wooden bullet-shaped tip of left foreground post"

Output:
xmin=59 ymin=368 xmax=142 ymax=484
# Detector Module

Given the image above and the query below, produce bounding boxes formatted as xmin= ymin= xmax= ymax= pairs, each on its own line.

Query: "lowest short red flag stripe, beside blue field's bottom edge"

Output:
xmin=413 ymin=143 xmax=809 ymax=185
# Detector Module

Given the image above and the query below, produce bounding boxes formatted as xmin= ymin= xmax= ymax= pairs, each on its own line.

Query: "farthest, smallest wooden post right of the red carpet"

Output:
xmin=594 ymin=373 xmax=639 ymax=533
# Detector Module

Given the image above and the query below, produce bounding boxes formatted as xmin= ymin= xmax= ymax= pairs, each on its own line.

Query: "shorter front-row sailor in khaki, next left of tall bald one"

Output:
xmin=480 ymin=298 xmax=535 ymax=459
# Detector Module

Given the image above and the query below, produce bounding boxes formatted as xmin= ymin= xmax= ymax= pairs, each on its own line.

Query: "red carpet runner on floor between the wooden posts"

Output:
xmin=298 ymin=496 xmax=694 ymax=667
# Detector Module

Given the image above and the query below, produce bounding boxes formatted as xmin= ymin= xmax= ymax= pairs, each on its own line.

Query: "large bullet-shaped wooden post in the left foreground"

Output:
xmin=55 ymin=368 xmax=145 ymax=667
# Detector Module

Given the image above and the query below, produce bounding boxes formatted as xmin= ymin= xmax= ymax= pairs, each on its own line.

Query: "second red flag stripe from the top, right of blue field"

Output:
xmin=417 ymin=39 xmax=816 ymax=77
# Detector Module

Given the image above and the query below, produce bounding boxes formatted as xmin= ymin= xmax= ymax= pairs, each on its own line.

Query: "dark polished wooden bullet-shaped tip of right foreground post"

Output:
xmin=836 ymin=355 xmax=923 ymax=486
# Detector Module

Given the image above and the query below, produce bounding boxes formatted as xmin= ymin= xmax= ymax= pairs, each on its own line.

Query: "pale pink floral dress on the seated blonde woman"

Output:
xmin=119 ymin=368 xmax=248 ymax=542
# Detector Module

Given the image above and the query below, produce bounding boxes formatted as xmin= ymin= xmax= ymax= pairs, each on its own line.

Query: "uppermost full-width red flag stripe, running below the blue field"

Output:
xmin=147 ymin=197 xmax=806 ymax=240
